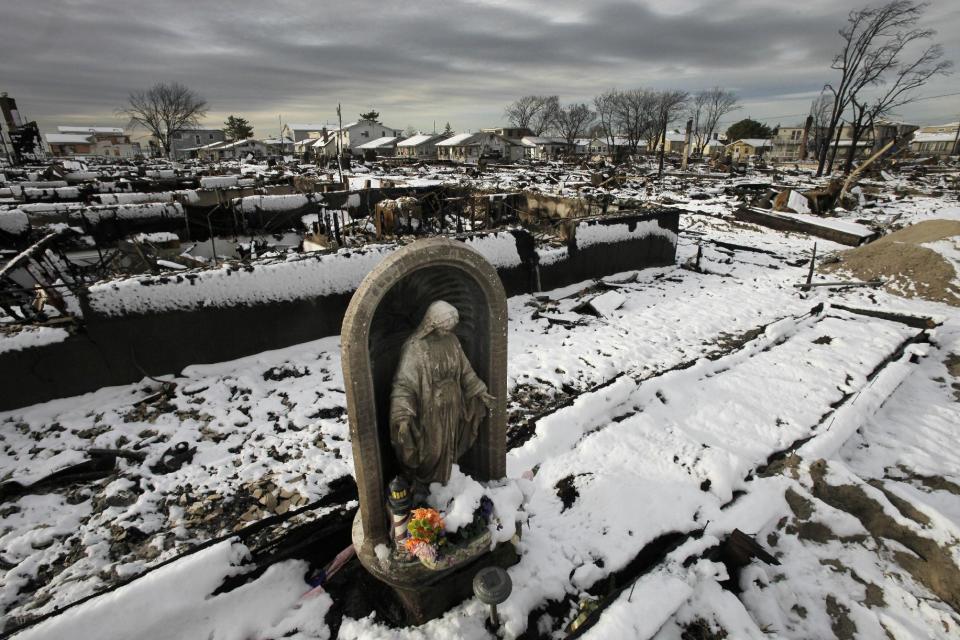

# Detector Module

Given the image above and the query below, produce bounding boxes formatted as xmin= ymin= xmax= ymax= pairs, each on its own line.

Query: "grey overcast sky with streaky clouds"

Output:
xmin=0 ymin=0 xmax=960 ymax=137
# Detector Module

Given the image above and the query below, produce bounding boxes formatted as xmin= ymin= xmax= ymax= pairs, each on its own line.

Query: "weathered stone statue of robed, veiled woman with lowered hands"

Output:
xmin=390 ymin=300 xmax=494 ymax=493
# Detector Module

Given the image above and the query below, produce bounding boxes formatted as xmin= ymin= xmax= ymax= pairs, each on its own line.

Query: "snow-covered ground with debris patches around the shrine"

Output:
xmin=0 ymin=168 xmax=960 ymax=639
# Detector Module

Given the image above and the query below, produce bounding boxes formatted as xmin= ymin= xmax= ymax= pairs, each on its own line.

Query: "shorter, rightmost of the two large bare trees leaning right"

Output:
xmin=843 ymin=41 xmax=953 ymax=174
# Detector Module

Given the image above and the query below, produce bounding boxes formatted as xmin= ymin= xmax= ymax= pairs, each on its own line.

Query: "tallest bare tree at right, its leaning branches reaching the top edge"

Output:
xmin=817 ymin=0 xmax=926 ymax=176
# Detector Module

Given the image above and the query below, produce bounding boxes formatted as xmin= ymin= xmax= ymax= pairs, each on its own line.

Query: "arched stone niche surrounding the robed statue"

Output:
xmin=341 ymin=238 xmax=507 ymax=559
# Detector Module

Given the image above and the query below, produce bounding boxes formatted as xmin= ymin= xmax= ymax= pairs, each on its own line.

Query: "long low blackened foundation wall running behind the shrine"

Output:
xmin=0 ymin=210 xmax=679 ymax=410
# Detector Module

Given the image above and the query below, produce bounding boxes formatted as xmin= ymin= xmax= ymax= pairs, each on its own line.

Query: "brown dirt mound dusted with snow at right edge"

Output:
xmin=821 ymin=220 xmax=960 ymax=307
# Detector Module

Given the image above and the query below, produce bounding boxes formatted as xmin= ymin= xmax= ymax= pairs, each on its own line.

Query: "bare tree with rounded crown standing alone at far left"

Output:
xmin=117 ymin=82 xmax=207 ymax=157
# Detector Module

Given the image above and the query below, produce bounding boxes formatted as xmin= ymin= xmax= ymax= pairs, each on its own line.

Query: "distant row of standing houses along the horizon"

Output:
xmin=39 ymin=119 xmax=960 ymax=164
